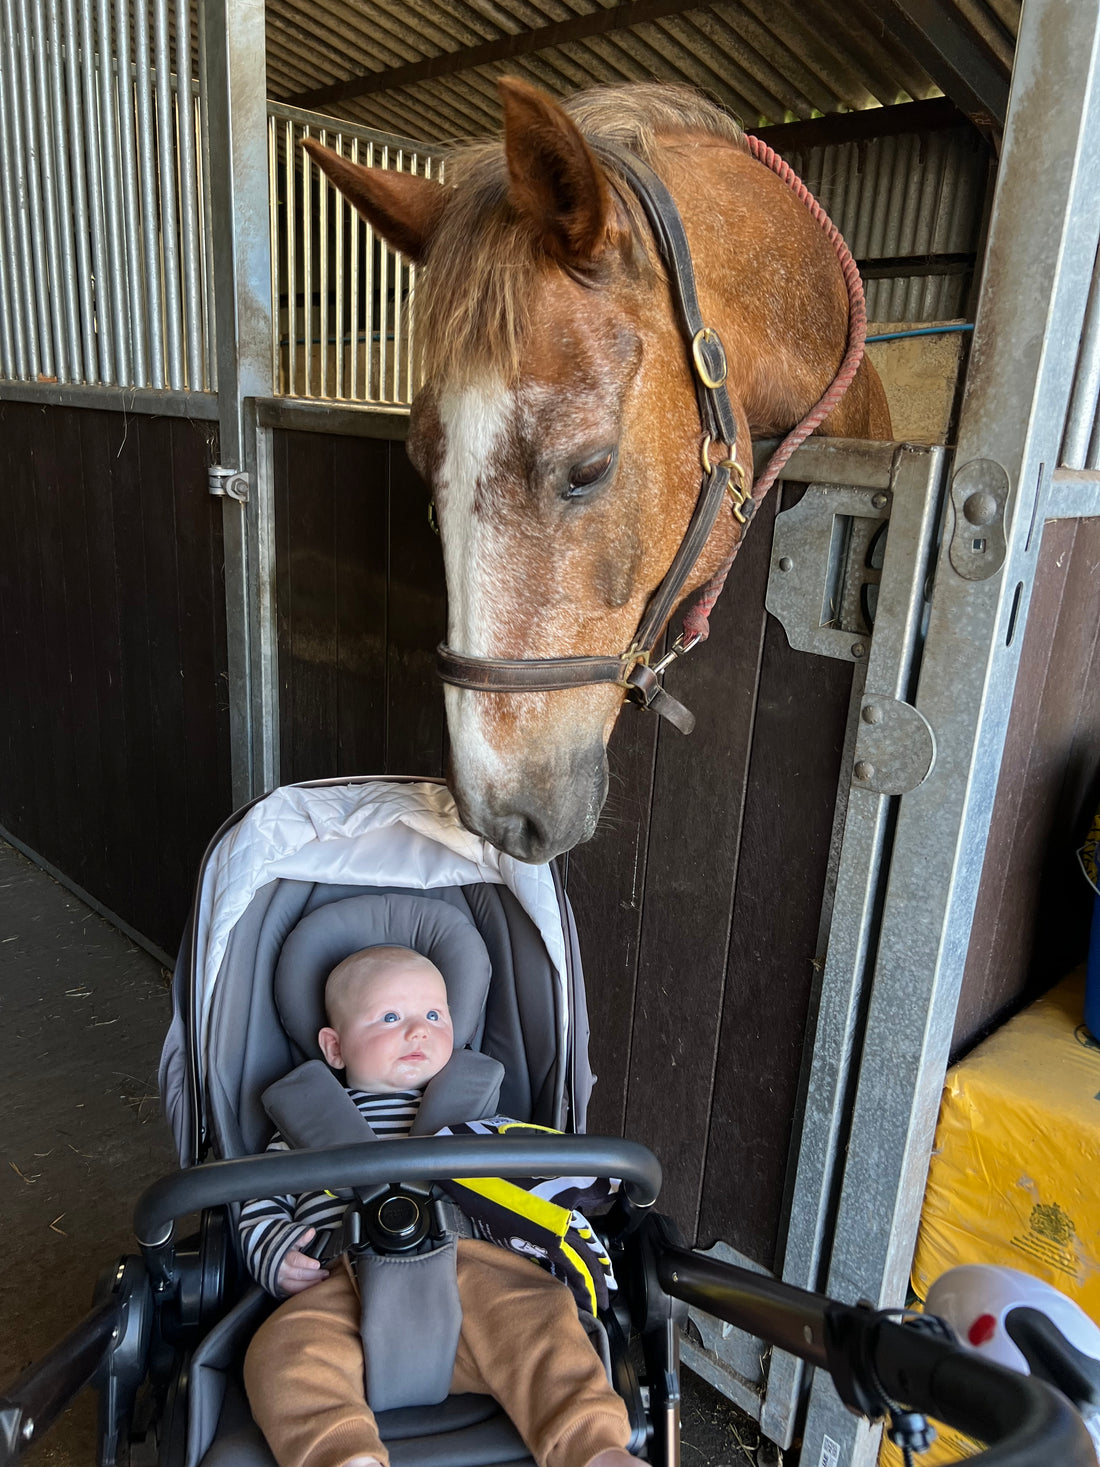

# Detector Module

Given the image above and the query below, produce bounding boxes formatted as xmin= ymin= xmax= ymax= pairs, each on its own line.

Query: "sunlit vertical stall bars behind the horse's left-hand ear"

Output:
xmin=267 ymin=104 xmax=443 ymax=406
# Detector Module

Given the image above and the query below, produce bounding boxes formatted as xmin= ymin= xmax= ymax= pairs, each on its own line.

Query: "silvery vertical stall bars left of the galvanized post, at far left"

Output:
xmin=0 ymin=0 xmax=214 ymax=396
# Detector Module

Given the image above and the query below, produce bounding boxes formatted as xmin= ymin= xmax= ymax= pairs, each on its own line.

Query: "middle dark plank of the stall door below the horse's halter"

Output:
xmin=623 ymin=500 xmax=774 ymax=1235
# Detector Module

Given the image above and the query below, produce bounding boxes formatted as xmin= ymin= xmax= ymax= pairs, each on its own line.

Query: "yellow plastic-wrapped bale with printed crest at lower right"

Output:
xmin=879 ymin=970 xmax=1100 ymax=1467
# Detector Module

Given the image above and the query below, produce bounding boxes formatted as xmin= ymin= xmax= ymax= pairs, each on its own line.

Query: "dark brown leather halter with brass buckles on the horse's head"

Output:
xmin=436 ymin=142 xmax=754 ymax=734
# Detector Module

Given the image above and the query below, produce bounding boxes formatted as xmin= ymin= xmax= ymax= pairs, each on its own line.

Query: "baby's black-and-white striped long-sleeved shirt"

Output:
xmin=238 ymin=1090 xmax=421 ymax=1298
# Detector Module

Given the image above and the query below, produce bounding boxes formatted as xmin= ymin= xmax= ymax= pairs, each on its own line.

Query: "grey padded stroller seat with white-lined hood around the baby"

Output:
xmin=153 ymin=780 xmax=645 ymax=1467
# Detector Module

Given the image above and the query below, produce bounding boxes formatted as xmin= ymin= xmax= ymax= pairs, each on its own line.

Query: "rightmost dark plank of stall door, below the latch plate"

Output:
xmin=709 ymin=601 xmax=852 ymax=1267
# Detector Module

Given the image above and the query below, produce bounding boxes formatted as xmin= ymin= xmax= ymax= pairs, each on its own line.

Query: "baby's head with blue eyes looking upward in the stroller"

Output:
xmin=317 ymin=961 xmax=455 ymax=1091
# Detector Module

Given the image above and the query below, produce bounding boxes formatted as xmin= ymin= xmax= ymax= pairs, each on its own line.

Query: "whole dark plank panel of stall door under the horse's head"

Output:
xmin=568 ymin=486 xmax=852 ymax=1267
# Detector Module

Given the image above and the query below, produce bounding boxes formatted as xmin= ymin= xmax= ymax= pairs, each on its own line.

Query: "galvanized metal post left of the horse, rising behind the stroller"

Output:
xmin=202 ymin=0 xmax=279 ymax=804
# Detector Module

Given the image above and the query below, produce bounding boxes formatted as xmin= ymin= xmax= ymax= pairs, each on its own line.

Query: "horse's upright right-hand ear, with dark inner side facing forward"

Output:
xmin=499 ymin=76 xmax=612 ymax=268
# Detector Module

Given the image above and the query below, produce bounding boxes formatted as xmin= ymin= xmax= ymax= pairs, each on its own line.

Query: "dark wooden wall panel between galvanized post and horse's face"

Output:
xmin=273 ymin=430 xmax=446 ymax=780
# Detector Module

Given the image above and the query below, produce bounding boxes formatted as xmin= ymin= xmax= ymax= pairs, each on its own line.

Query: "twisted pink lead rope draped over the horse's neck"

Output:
xmin=682 ymin=136 xmax=867 ymax=648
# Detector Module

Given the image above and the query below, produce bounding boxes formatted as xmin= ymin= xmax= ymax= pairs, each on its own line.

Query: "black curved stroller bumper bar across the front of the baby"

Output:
xmin=133 ymin=1134 xmax=661 ymax=1248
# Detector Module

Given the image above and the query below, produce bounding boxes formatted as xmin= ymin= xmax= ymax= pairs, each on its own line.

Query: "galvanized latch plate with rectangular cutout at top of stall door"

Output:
xmin=764 ymin=484 xmax=892 ymax=662
